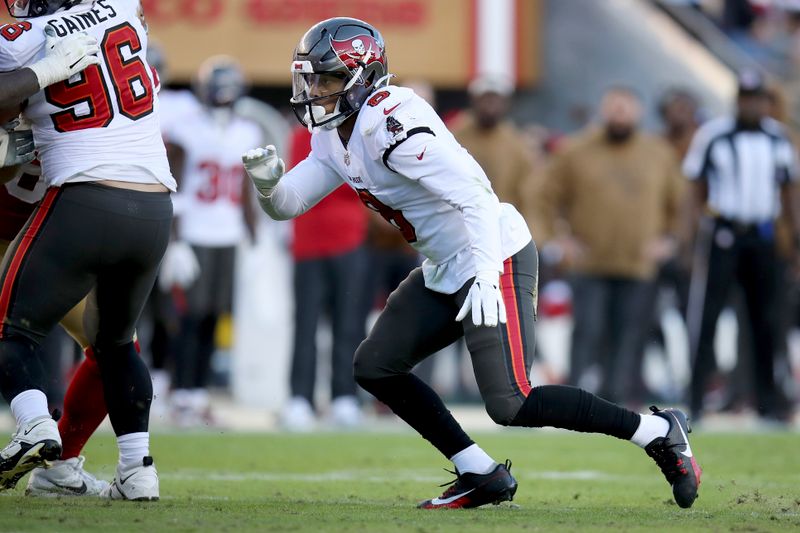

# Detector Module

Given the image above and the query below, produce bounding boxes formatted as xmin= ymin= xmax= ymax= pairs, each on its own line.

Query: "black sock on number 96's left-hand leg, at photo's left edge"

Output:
xmin=0 ymin=335 xmax=42 ymax=404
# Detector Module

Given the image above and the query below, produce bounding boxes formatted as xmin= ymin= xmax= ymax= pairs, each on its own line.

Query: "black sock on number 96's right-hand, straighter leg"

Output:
xmin=95 ymin=342 xmax=153 ymax=436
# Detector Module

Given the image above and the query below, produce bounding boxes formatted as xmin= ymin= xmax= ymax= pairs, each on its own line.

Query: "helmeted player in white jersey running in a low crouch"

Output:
xmin=243 ymin=18 xmax=700 ymax=509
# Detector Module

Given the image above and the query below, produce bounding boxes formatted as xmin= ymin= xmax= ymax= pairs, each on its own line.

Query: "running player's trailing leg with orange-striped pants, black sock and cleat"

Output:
xmin=468 ymin=243 xmax=700 ymax=507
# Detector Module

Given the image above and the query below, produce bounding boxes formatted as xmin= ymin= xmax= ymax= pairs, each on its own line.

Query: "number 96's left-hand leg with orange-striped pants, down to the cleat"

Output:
xmin=0 ymin=189 xmax=94 ymax=489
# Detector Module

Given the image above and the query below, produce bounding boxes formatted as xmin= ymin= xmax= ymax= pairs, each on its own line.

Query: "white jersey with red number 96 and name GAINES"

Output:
xmin=0 ymin=0 xmax=175 ymax=190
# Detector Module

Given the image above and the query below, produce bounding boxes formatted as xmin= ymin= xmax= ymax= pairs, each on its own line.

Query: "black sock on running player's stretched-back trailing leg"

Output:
xmin=511 ymin=385 xmax=639 ymax=440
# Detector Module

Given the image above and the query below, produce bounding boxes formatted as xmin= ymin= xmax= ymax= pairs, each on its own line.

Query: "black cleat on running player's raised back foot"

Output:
xmin=644 ymin=406 xmax=703 ymax=509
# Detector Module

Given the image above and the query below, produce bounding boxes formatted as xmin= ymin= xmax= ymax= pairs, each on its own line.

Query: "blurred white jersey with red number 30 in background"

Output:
xmin=169 ymin=111 xmax=262 ymax=247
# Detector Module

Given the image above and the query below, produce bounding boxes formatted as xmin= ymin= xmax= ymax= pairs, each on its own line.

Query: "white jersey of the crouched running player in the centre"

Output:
xmin=275 ymin=86 xmax=531 ymax=294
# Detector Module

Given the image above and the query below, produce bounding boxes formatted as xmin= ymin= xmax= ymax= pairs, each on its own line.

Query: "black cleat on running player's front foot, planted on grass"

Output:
xmin=417 ymin=461 xmax=517 ymax=509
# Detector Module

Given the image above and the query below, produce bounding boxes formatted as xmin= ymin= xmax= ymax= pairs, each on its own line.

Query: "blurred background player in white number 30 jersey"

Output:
xmin=159 ymin=56 xmax=263 ymax=426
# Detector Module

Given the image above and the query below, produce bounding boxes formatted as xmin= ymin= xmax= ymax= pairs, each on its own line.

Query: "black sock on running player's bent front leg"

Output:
xmin=358 ymin=374 xmax=474 ymax=459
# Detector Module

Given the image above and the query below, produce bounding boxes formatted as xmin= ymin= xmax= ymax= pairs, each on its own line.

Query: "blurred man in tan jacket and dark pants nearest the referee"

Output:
xmin=532 ymin=87 xmax=683 ymax=402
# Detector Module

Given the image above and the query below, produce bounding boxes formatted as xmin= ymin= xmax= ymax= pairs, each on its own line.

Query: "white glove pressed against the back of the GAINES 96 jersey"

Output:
xmin=28 ymin=26 xmax=100 ymax=89
